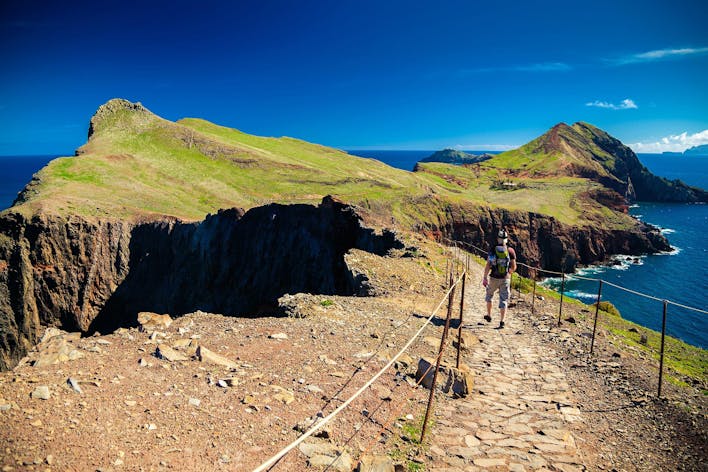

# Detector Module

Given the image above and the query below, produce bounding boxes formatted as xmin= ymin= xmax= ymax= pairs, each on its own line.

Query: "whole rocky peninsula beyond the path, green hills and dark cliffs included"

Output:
xmin=0 ymin=99 xmax=706 ymax=369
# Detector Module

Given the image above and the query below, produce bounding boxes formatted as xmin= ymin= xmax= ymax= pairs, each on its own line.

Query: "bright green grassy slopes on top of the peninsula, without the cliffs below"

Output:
xmin=6 ymin=99 xmax=634 ymax=228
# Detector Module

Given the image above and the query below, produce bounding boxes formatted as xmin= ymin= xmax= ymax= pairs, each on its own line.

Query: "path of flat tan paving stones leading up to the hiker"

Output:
xmin=427 ymin=274 xmax=586 ymax=472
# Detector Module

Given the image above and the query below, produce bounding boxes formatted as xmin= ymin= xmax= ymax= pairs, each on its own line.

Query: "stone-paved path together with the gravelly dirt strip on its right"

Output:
xmin=427 ymin=260 xmax=708 ymax=471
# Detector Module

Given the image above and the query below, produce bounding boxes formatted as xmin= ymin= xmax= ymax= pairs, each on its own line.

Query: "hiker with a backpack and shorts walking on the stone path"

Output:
xmin=482 ymin=229 xmax=516 ymax=329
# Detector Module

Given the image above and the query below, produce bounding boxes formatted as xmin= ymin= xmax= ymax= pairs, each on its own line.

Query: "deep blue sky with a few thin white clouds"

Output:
xmin=0 ymin=0 xmax=708 ymax=154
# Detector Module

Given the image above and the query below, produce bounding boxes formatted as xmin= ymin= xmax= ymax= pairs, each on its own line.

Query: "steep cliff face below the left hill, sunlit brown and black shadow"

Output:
xmin=0 ymin=198 xmax=402 ymax=370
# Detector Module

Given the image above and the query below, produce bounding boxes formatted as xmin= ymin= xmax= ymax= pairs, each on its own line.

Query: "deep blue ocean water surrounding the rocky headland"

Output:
xmin=0 ymin=150 xmax=708 ymax=349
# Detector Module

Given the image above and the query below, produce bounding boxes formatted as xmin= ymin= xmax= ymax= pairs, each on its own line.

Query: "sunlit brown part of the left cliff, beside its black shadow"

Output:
xmin=0 ymin=214 xmax=131 ymax=369
